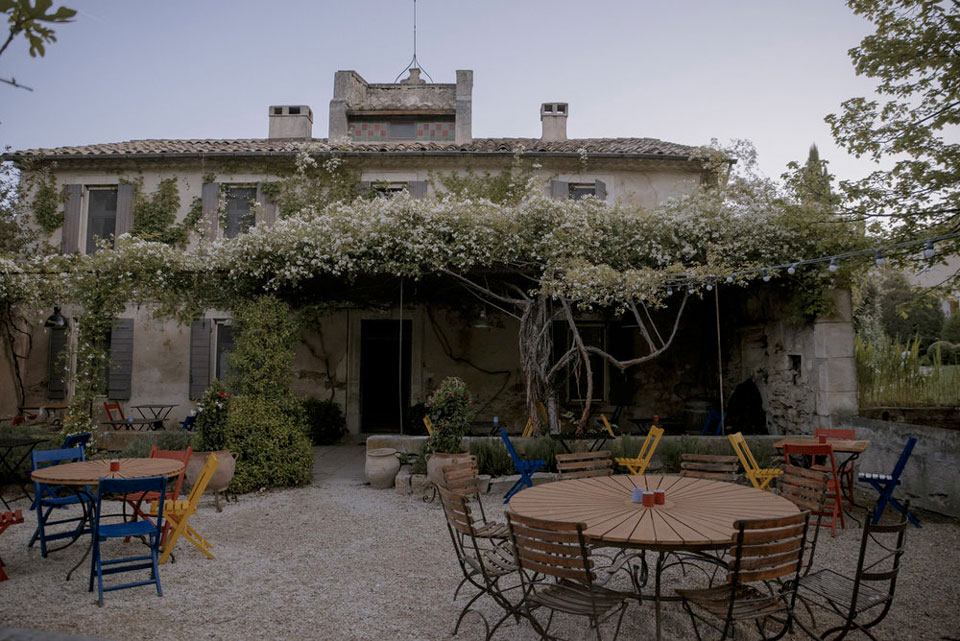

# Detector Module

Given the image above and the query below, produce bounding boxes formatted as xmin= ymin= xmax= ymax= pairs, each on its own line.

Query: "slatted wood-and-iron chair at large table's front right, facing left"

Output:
xmin=677 ymin=512 xmax=810 ymax=640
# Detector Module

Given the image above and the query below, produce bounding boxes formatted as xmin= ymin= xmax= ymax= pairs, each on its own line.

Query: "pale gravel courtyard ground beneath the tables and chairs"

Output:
xmin=0 ymin=445 xmax=960 ymax=641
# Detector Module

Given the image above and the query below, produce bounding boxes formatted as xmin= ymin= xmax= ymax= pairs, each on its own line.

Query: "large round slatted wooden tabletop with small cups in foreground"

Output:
xmin=510 ymin=474 xmax=799 ymax=550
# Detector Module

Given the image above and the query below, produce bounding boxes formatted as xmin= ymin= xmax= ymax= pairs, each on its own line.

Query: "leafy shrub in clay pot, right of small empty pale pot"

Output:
xmin=425 ymin=376 xmax=473 ymax=485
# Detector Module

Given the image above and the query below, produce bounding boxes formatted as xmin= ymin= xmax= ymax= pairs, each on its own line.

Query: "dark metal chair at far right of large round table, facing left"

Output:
xmin=797 ymin=501 xmax=910 ymax=641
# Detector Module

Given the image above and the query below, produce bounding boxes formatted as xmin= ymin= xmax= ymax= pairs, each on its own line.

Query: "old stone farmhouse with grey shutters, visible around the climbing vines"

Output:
xmin=0 ymin=69 xmax=857 ymax=434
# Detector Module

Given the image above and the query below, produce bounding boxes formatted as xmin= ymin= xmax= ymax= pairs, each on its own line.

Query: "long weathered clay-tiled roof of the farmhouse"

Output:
xmin=8 ymin=138 xmax=695 ymax=159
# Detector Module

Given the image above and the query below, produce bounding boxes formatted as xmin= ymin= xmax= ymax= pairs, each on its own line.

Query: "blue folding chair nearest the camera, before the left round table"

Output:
xmin=89 ymin=476 xmax=167 ymax=605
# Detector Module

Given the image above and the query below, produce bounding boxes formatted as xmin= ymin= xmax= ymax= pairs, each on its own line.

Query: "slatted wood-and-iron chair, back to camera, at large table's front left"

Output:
xmin=507 ymin=512 xmax=637 ymax=641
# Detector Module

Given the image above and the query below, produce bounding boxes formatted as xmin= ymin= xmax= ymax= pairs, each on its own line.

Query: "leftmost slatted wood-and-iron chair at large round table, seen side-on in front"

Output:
xmin=437 ymin=484 xmax=519 ymax=640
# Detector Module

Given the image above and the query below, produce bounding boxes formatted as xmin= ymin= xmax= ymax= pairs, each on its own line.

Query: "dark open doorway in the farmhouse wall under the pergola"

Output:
xmin=360 ymin=320 xmax=412 ymax=432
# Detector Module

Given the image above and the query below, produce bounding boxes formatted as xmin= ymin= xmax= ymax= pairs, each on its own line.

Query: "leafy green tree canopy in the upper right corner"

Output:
xmin=826 ymin=0 xmax=960 ymax=237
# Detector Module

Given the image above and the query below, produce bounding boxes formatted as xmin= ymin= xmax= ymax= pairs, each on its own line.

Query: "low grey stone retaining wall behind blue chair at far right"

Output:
xmin=835 ymin=416 xmax=960 ymax=517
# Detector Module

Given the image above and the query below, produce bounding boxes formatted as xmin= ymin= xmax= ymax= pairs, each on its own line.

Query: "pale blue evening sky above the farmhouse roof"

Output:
xmin=0 ymin=0 xmax=875 ymax=186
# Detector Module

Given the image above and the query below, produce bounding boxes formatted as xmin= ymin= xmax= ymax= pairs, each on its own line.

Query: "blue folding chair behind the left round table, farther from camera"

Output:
xmin=27 ymin=447 xmax=91 ymax=558
